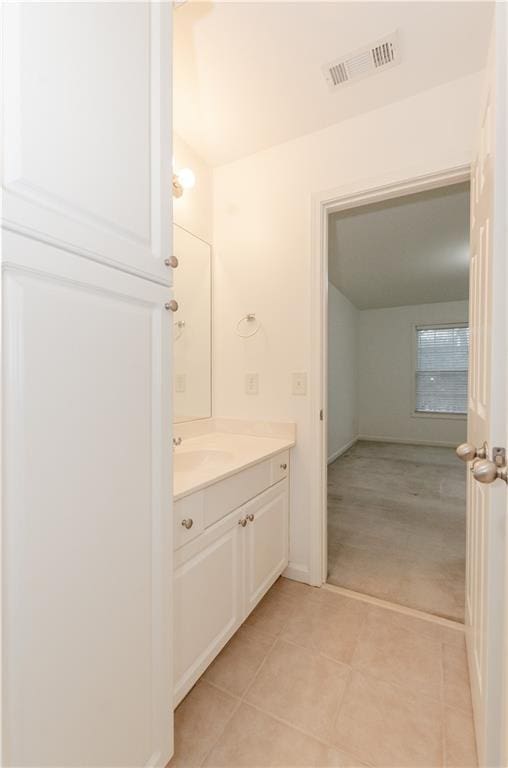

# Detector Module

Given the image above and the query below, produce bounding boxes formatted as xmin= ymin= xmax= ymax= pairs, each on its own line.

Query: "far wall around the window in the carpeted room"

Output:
xmin=358 ymin=301 xmax=468 ymax=445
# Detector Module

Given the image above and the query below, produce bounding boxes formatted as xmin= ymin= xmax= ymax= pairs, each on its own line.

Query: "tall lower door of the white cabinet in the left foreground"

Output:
xmin=3 ymin=232 xmax=172 ymax=768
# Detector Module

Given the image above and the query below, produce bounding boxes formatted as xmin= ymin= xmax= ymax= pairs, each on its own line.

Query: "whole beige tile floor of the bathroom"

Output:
xmin=170 ymin=578 xmax=476 ymax=768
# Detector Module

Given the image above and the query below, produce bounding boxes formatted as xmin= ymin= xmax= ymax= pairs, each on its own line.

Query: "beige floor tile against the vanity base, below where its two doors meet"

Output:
xmin=203 ymin=625 xmax=274 ymax=696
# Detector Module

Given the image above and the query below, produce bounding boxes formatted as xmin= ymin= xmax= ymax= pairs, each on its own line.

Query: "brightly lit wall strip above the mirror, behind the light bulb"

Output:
xmin=173 ymin=133 xmax=213 ymax=243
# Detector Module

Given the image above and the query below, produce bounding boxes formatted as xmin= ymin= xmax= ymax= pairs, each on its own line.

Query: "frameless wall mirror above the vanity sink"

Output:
xmin=173 ymin=224 xmax=212 ymax=423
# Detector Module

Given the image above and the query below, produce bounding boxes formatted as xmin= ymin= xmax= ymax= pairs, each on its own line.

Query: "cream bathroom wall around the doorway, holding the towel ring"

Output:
xmin=214 ymin=74 xmax=482 ymax=579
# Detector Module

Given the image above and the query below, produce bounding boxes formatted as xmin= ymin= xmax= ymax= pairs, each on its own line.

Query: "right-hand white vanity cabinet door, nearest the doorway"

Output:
xmin=242 ymin=480 xmax=288 ymax=615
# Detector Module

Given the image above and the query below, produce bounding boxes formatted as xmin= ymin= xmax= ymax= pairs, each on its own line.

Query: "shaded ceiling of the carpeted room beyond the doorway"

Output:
xmin=328 ymin=184 xmax=469 ymax=309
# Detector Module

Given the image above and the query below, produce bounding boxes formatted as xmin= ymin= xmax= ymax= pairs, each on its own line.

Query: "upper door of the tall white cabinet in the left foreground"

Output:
xmin=2 ymin=2 xmax=171 ymax=284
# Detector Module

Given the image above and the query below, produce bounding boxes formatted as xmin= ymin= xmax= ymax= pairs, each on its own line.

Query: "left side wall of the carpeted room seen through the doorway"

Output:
xmin=327 ymin=283 xmax=360 ymax=462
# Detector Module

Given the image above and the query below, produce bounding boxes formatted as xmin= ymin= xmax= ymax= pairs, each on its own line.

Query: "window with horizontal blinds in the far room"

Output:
xmin=415 ymin=325 xmax=469 ymax=414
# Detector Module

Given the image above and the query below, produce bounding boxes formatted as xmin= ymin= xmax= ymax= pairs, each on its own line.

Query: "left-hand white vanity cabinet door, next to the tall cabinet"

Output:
xmin=174 ymin=515 xmax=244 ymax=704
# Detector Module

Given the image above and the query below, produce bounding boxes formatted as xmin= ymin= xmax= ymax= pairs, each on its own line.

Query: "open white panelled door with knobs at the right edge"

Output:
xmin=466 ymin=3 xmax=508 ymax=766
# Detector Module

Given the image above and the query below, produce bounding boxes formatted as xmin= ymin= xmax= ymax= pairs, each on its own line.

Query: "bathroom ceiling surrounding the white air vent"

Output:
xmin=173 ymin=0 xmax=492 ymax=165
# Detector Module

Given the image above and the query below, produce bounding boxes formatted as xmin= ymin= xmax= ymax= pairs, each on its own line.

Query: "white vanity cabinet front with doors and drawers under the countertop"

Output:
xmin=174 ymin=451 xmax=289 ymax=705
